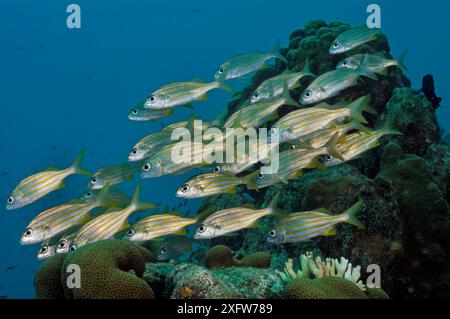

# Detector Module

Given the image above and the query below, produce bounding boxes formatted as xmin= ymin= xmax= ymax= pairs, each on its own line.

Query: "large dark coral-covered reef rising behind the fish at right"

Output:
xmin=194 ymin=20 xmax=450 ymax=298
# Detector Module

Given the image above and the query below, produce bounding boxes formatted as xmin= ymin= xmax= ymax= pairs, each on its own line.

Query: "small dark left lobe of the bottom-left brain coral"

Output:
xmin=34 ymin=254 xmax=67 ymax=299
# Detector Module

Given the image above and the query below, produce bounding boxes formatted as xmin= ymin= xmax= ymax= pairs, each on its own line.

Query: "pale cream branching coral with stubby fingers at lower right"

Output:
xmin=277 ymin=251 xmax=366 ymax=291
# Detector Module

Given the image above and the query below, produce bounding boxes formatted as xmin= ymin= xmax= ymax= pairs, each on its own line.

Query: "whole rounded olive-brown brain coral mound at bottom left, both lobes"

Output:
xmin=35 ymin=240 xmax=154 ymax=299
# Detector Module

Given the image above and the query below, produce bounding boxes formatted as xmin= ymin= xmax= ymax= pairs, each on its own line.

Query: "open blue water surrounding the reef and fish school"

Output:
xmin=0 ymin=0 xmax=450 ymax=298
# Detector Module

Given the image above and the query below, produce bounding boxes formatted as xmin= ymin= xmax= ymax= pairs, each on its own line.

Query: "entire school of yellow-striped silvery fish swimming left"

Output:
xmin=6 ymin=26 xmax=406 ymax=261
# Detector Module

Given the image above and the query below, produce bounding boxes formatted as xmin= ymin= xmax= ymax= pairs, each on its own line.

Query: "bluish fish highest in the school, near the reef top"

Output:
xmin=330 ymin=25 xmax=383 ymax=54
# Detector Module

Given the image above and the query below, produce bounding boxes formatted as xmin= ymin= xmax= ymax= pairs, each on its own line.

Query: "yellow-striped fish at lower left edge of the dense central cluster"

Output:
xmin=176 ymin=172 xmax=256 ymax=198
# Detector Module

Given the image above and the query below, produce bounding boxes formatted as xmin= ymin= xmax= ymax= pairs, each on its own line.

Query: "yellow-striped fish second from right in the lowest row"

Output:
xmin=194 ymin=194 xmax=279 ymax=239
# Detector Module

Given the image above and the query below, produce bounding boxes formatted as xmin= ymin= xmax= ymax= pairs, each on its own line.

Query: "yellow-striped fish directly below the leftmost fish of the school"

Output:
xmin=20 ymin=187 xmax=109 ymax=245
